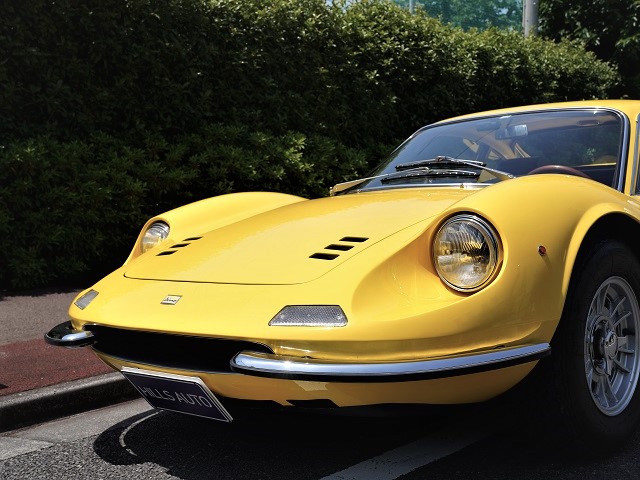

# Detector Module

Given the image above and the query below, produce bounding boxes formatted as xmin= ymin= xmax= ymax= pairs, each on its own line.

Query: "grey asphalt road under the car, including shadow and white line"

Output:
xmin=0 ymin=400 xmax=640 ymax=480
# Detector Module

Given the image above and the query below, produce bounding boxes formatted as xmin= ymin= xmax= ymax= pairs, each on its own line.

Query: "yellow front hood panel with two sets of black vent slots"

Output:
xmin=125 ymin=188 xmax=473 ymax=285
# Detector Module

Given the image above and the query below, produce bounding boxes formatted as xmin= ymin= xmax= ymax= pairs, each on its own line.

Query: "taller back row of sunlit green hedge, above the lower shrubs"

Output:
xmin=0 ymin=0 xmax=616 ymax=144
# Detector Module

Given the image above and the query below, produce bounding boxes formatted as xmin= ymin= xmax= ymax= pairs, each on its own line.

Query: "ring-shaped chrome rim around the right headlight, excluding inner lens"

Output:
xmin=431 ymin=213 xmax=502 ymax=293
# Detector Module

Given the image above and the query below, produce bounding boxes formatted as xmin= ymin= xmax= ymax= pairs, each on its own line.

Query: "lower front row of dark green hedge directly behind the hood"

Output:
xmin=0 ymin=125 xmax=365 ymax=288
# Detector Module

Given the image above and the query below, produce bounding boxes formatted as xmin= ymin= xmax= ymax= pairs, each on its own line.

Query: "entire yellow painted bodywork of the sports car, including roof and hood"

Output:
xmin=48 ymin=101 xmax=640 ymax=416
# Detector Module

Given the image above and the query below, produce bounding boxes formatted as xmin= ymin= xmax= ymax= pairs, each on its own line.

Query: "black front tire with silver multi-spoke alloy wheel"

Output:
xmin=547 ymin=241 xmax=640 ymax=453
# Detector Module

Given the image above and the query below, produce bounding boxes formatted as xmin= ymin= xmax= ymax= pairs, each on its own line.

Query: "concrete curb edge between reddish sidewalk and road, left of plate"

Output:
xmin=0 ymin=372 xmax=139 ymax=433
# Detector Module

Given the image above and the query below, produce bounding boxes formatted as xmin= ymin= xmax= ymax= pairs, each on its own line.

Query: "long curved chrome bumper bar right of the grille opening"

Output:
xmin=231 ymin=343 xmax=551 ymax=382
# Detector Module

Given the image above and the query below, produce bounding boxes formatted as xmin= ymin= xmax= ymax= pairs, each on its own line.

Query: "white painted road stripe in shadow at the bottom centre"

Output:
xmin=320 ymin=427 xmax=491 ymax=480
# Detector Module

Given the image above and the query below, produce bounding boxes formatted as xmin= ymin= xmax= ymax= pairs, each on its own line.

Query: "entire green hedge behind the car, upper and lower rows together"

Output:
xmin=0 ymin=0 xmax=617 ymax=288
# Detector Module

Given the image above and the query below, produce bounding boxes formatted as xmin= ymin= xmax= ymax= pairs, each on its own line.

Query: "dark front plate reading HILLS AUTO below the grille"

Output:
xmin=122 ymin=367 xmax=233 ymax=422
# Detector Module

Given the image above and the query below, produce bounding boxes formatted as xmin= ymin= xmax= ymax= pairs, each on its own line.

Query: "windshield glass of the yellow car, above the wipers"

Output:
xmin=358 ymin=109 xmax=624 ymax=190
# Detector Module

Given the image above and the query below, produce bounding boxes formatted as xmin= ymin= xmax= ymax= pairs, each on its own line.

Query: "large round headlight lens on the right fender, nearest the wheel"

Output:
xmin=433 ymin=214 xmax=500 ymax=292
